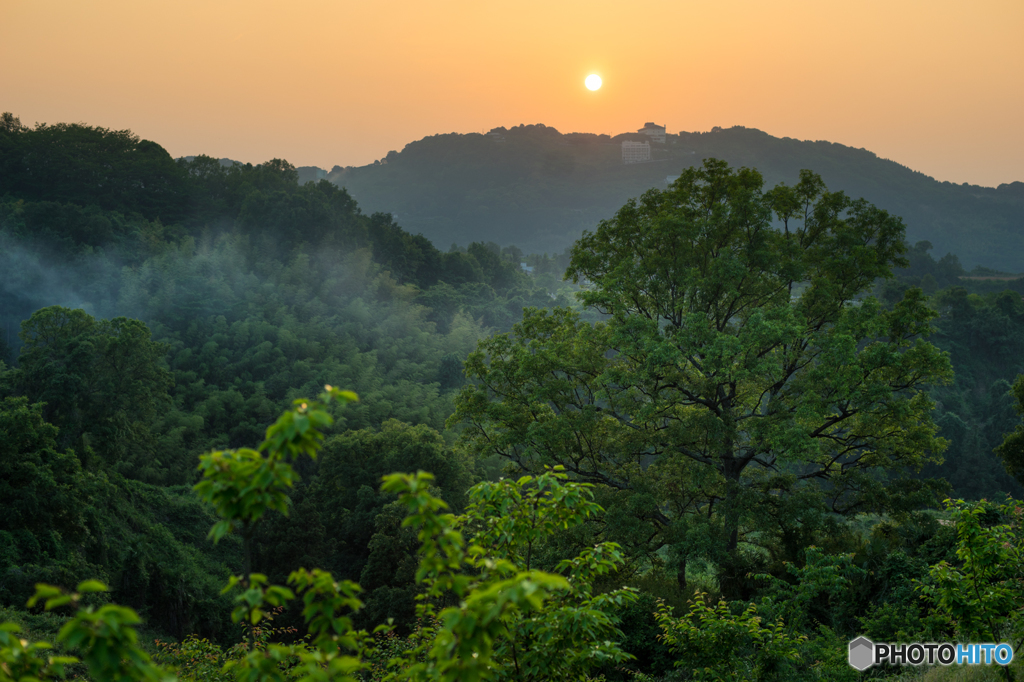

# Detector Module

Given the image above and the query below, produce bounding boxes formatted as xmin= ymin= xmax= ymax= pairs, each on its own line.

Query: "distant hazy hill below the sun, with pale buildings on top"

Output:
xmin=329 ymin=125 xmax=1024 ymax=272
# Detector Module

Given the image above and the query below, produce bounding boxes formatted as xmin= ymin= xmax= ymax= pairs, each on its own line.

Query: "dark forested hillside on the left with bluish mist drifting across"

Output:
xmin=0 ymin=115 xmax=564 ymax=637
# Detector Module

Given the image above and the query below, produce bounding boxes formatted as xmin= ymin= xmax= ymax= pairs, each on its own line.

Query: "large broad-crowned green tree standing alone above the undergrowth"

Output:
xmin=451 ymin=160 xmax=950 ymax=588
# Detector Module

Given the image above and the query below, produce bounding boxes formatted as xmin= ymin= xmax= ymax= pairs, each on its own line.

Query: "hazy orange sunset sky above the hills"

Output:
xmin=0 ymin=0 xmax=1024 ymax=185
